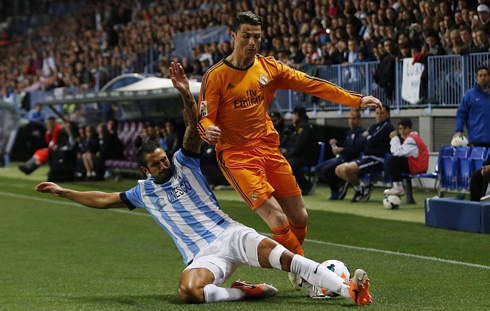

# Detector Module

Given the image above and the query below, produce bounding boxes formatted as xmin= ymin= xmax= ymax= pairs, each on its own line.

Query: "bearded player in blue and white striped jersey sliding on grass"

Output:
xmin=36 ymin=63 xmax=371 ymax=305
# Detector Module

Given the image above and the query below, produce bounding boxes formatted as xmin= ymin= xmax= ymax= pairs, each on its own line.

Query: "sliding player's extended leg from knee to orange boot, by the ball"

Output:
xmin=258 ymin=238 xmax=371 ymax=305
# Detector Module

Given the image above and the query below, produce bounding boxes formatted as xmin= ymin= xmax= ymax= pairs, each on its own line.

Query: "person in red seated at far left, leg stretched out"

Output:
xmin=19 ymin=117 xmax=61 ymax=175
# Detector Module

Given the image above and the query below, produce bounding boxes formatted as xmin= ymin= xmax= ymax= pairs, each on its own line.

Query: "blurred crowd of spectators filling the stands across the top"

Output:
xmin=0 ymin=0 xmax=490 ymax=106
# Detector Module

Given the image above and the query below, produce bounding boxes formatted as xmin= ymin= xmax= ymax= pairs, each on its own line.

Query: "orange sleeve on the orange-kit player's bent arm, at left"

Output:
xmin=197 ymin=70 xmax=221 ymax=145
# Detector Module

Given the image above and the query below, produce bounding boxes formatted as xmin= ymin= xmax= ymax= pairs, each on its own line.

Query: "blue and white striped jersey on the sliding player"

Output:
xmin=120 ymin=149 xmax=233 ymax=264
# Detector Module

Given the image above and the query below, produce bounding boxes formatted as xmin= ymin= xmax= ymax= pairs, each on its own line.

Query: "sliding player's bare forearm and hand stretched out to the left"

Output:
xmin=36 ymin=182 xmax=126 ymax=209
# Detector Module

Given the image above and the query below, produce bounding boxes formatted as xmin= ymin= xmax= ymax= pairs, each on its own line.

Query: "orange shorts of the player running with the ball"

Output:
xmin=217 ymin=143 xmax=301 ymax=210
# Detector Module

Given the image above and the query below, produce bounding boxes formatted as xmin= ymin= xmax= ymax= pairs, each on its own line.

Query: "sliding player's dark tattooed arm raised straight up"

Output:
xmin=169 ymin=62 xmax=201 ymax=153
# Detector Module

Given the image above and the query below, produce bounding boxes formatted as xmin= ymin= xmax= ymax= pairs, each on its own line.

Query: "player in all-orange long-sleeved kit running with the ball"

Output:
xmin=198 ymin=12 xmax=381 ymax=289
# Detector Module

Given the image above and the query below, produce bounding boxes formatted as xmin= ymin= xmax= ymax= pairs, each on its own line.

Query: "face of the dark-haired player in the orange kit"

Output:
xmin=232 ymin=24 xmax=262 ymax=58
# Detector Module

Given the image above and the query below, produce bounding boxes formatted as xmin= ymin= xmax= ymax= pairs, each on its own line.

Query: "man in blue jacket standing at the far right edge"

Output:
xmin=454 ymin=66 xmax=490 ymax=148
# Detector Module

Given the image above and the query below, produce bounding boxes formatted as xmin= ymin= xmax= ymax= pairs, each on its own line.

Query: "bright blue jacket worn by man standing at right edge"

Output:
xmin=456 ymin=84 xmax=490 ymax=144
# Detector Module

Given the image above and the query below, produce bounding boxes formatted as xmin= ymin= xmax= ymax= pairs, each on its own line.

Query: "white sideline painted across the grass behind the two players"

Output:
xmin=0 ymin=191 xmax=490 ymax=270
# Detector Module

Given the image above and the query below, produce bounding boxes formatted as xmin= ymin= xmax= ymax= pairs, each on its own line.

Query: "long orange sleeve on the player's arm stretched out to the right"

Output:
xmin=274 ymin=60 xmax=364 ymax=109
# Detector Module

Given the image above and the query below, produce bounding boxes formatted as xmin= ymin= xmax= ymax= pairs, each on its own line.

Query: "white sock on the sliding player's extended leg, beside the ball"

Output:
xmin=291 ymin=255 xmax=351 ymax=299
